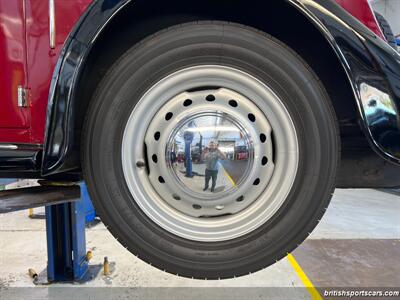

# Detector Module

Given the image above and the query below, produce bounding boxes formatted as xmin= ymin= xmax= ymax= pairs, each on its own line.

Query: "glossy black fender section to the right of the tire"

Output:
xmin=299 ymin=0 xmax=400 ymax=164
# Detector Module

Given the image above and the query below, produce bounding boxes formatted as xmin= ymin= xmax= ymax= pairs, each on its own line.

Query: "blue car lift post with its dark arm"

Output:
xmin=0 ymin=184 xmax=95 ymax=282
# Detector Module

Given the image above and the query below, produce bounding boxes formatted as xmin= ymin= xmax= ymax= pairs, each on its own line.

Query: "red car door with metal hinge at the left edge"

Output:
xmin=0 ymin=0 xmax=30 ymax=143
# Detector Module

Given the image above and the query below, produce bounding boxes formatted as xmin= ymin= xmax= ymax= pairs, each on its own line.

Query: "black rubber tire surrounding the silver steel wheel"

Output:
xmin=82 ymin=21 xmax=340 ymax=279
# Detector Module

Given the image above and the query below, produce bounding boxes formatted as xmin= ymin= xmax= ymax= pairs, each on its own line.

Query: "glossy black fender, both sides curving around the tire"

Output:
xmin=42 ymin=0 xmax=400 ymax=176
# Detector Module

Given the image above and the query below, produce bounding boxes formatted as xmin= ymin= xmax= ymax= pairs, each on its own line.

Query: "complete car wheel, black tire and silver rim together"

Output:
xmin=82 ymin=21 xmax=339 ymax=279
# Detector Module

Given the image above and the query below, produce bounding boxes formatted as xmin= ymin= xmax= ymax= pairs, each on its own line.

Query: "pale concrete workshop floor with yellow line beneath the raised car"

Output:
xmin=0 ymin=190 xmax=400 ymax=299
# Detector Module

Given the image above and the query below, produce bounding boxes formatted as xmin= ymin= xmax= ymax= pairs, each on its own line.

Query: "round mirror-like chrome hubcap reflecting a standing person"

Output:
xmin=166 ymin=112 xmax=254 ymax=197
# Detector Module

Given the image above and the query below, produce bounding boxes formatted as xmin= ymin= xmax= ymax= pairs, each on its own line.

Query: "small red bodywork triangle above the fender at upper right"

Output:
xmin=335 ymin=0 xmax=385 ymax=40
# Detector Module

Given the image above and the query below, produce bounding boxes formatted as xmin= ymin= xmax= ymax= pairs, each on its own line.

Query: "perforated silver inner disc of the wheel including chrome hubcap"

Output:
xmin=145 ymin=88 xmax=274 ymax=217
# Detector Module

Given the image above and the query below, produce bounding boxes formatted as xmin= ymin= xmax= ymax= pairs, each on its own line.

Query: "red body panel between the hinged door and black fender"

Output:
xmin=25 ymin=0 xmax=92 ymax=143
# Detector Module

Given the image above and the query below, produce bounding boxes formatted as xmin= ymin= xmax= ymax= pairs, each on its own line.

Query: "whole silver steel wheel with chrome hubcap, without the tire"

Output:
xmin=122 ymin=65 xmax=299 ymax=242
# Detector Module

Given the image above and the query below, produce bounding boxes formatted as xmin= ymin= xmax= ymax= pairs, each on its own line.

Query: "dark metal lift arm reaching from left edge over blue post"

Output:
xmin=0 ymin=185 xmax=81 ymax=214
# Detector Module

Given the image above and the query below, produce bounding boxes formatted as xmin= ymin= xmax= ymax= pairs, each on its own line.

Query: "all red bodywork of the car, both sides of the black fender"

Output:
xmin=0 ymin=0 xmax=383 ymax=144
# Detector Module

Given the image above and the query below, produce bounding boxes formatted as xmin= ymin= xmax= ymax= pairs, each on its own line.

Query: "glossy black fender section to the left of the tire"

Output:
xmin=42 ymin=0 xmax=130 ymax=176
